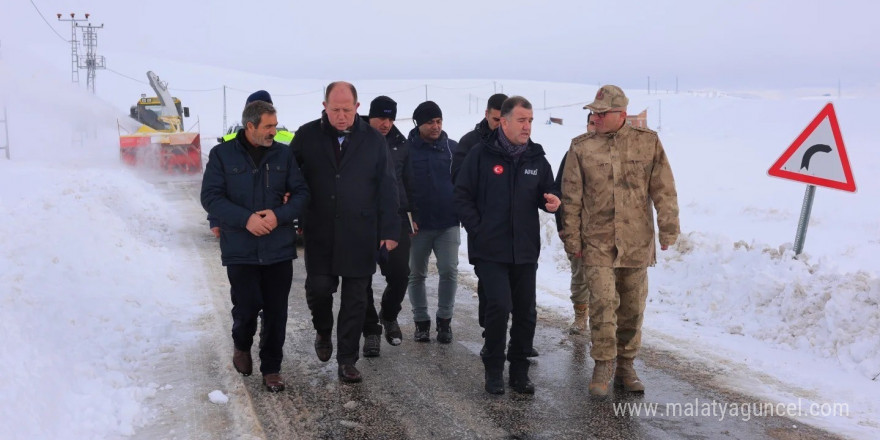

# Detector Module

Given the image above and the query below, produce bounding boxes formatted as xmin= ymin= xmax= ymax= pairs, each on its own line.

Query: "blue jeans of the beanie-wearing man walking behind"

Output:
xmin=408 ymin=226 xmax=461 ymax=321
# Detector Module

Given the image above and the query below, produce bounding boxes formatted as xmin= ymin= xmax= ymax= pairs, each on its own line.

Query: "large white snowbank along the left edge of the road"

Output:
xmin=0 ymin=161 xmax=203 ymax=438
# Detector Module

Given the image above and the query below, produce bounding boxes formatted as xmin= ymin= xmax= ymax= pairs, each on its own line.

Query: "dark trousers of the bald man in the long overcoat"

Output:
xmin=306 ymin=274 xmax=371 ymax=365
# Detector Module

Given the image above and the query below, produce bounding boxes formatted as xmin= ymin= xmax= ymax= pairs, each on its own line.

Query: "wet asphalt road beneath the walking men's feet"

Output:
xmin=232 ymin=260 xmax=835 ymax=439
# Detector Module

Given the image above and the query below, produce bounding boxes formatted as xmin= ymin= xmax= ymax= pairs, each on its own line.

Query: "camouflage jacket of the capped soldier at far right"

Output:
xmin=562 ymin=125 xmax=679 ymax=267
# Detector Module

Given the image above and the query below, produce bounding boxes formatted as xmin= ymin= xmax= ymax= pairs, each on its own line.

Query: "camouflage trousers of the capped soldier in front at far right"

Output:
xmin=585 ymin=266 xmax=648 ymax=361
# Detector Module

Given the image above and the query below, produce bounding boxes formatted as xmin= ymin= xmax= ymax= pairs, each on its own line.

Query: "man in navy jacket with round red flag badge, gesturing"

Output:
xmin=455 ymin=96 xmax=560 ymax=394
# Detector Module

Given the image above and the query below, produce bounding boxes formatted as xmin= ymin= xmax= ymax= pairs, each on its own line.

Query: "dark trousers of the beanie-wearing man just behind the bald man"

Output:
xmin=363 ymin=221 xmax=411 ymax=336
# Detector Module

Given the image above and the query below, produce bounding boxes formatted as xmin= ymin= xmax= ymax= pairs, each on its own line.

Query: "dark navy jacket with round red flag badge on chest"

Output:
xmin=455 ymin=132 xmax=558 ymax=264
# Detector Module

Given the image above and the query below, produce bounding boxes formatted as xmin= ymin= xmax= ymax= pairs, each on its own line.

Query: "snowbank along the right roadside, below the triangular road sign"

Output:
xmin=649 ymin=232 xmax=880 ymax=379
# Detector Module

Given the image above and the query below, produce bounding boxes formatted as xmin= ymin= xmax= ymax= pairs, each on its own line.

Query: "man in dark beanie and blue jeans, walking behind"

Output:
xmin=407 ymin=101 xmax=461 ymax=344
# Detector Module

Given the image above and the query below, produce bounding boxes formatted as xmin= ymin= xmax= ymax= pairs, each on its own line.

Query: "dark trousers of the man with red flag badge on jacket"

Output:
xmin=476 ymin=260 xmax=538 ymax=370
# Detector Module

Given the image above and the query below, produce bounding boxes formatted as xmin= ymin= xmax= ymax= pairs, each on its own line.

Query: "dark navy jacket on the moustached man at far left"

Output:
xmin=201 ymin=131 xmax=309 ymax=266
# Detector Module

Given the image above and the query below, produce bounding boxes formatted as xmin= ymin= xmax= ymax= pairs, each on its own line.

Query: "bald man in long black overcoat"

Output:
xmin=290 ymin=81 xmax=400 ymax=382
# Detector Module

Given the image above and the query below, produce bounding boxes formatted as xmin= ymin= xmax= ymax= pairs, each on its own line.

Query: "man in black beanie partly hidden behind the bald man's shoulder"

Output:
xmin=363 ymin=96 xmax=418 ymax=357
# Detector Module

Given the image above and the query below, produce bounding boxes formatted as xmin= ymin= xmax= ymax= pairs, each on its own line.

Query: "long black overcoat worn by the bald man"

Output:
xmin=290 ymin=113 xmax=400 ymax=277
